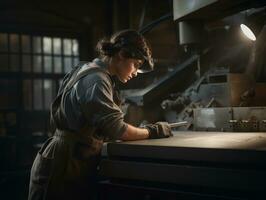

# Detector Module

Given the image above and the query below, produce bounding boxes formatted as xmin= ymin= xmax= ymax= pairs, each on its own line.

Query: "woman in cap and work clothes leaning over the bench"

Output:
xmin=29 ymin=30 xmax=171 ymax=200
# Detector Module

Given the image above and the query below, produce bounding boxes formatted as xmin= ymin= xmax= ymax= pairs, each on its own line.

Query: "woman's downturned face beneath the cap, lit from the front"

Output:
xmin=116 ymin=58 xmax=143 ymax=83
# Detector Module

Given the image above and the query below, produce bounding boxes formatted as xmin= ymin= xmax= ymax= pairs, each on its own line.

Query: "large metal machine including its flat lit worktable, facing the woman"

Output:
xmin=99 ymin=0 xmax=266 ymax=199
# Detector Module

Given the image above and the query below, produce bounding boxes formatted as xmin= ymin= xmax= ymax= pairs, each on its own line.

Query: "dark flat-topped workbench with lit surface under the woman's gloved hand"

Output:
xmin=99 ymin=131 xmax=266 ymax=199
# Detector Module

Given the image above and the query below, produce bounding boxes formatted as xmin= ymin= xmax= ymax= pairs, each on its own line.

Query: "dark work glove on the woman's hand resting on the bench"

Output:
xmin=145 ymin=122 xmax=173 ymax=139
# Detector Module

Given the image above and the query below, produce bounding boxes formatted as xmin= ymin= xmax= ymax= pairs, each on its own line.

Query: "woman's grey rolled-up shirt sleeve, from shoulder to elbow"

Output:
xmin=81 ymin=80 xmax=127 ymax=139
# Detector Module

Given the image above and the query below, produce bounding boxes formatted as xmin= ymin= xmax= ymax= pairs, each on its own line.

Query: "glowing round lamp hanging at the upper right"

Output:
xmin=240 ymin=9 xmax=266 ymax=41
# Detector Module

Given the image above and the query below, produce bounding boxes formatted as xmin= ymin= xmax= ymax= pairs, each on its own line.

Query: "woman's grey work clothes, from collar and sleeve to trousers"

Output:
xmin=28 ymin=59 xmax=127 ymax=200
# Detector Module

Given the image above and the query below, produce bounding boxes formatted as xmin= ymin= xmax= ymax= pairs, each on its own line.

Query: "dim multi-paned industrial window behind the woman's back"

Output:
xmin=0 ymin=32 xmax=79 ymax=111
